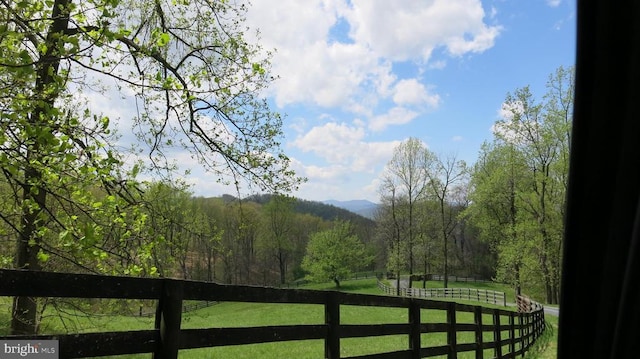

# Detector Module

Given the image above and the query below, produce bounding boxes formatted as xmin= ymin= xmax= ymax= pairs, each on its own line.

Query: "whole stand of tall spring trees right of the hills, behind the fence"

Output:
xmin=376 ymin=67 xmax=574 ymax=304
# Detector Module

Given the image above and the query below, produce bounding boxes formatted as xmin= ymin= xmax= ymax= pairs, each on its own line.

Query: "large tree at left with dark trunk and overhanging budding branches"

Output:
xmin=0 ymin=0 xmax=299 ymax=334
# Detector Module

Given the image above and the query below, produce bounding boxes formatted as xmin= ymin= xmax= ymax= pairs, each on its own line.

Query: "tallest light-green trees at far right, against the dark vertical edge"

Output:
xmin=468 ymin=67 xmax=574 ymax=304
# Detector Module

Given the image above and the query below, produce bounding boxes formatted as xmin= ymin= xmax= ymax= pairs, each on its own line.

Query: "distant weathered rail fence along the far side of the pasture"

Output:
xmin=378 ymin=281 xmax=507 ymax=306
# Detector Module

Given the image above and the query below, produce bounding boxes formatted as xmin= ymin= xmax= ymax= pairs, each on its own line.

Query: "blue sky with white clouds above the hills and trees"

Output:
xmin=117 ymin=0 xmax=576 ymax=202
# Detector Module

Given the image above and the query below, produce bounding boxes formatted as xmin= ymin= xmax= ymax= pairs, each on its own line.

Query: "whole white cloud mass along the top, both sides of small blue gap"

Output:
xmin=247 ymin=0 xmax=500 ymax=114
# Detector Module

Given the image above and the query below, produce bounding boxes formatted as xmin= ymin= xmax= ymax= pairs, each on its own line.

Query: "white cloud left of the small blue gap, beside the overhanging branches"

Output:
xmin=247 ymin=0 xmax=390 ymax=107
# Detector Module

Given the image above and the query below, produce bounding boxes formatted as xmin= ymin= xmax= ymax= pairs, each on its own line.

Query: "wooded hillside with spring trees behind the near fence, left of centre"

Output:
xmin=0 ymin=182 xmax=376 ymax=332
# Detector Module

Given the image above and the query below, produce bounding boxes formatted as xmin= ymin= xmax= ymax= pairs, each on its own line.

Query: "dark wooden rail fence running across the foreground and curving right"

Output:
xmin=0 ymin=269 xmax=544 ymax=359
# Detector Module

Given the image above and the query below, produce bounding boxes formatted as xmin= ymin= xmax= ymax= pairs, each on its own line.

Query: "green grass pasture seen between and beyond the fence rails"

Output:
xmin=0 ymin=279 xmax=557 ymax=359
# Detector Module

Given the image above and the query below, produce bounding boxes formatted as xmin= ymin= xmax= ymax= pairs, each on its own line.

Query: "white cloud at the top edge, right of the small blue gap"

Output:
xmin=346 ymin=0 xmax=501 ymax=62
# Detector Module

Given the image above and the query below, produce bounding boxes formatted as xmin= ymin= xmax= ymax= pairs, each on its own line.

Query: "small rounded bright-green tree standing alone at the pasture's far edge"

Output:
xmin=302 ymin=222 xmax=371 ymax=288
